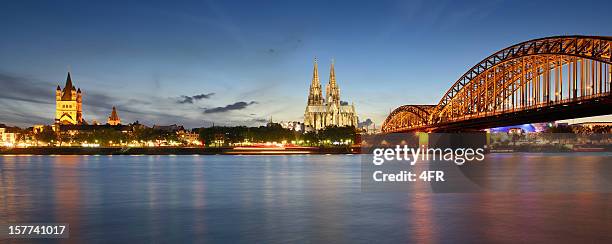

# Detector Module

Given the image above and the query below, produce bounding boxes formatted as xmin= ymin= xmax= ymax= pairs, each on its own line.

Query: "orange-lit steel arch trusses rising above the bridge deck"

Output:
xmin=383 ymin=36 xmax=612 ymax=132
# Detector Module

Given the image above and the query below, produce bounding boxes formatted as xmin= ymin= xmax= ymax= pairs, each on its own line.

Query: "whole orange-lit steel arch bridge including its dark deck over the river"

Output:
xmin=382 ymin=36 xmax=612 ymax=133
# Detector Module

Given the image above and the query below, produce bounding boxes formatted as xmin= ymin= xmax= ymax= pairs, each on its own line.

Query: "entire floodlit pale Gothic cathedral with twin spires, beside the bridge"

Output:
xmin=304 ymin=59 xmax=357 ymax=130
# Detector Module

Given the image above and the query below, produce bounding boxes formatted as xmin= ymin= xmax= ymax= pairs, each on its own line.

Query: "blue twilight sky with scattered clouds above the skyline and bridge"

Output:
xmin=0 ymin=0 xmax=612 ymax=127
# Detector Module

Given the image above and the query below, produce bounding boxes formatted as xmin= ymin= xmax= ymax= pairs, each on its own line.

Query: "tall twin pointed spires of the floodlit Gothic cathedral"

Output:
xmin=308 ymin=58 xmax=340 ymax=106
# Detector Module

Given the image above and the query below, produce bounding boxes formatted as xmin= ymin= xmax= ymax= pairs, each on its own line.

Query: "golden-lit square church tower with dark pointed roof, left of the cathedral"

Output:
xmin=55 ymin=72 xmax=83 ymax=125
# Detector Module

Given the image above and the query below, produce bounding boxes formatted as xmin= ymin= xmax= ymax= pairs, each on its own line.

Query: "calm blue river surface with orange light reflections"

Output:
xmin=0 ymin=155 xmax=612 ymax=243
